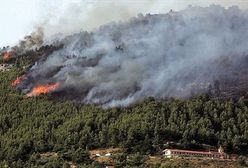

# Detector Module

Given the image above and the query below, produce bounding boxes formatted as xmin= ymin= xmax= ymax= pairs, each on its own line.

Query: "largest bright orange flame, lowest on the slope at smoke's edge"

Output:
xmin=26 ymin=83 xmax=60 ymax=97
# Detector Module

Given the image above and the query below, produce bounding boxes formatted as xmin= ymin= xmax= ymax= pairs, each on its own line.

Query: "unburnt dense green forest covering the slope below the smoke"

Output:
xmin=0 ymin=50 xmax=248 ymax=167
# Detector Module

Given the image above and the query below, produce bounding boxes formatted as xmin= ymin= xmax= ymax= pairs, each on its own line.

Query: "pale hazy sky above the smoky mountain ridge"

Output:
xmin=0 ymin=0 xmax=248 ymax=46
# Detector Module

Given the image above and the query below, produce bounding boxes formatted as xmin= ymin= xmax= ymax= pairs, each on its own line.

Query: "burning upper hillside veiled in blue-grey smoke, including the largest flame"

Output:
xmin=7 ymin=6 xmax=248 ymax=106
